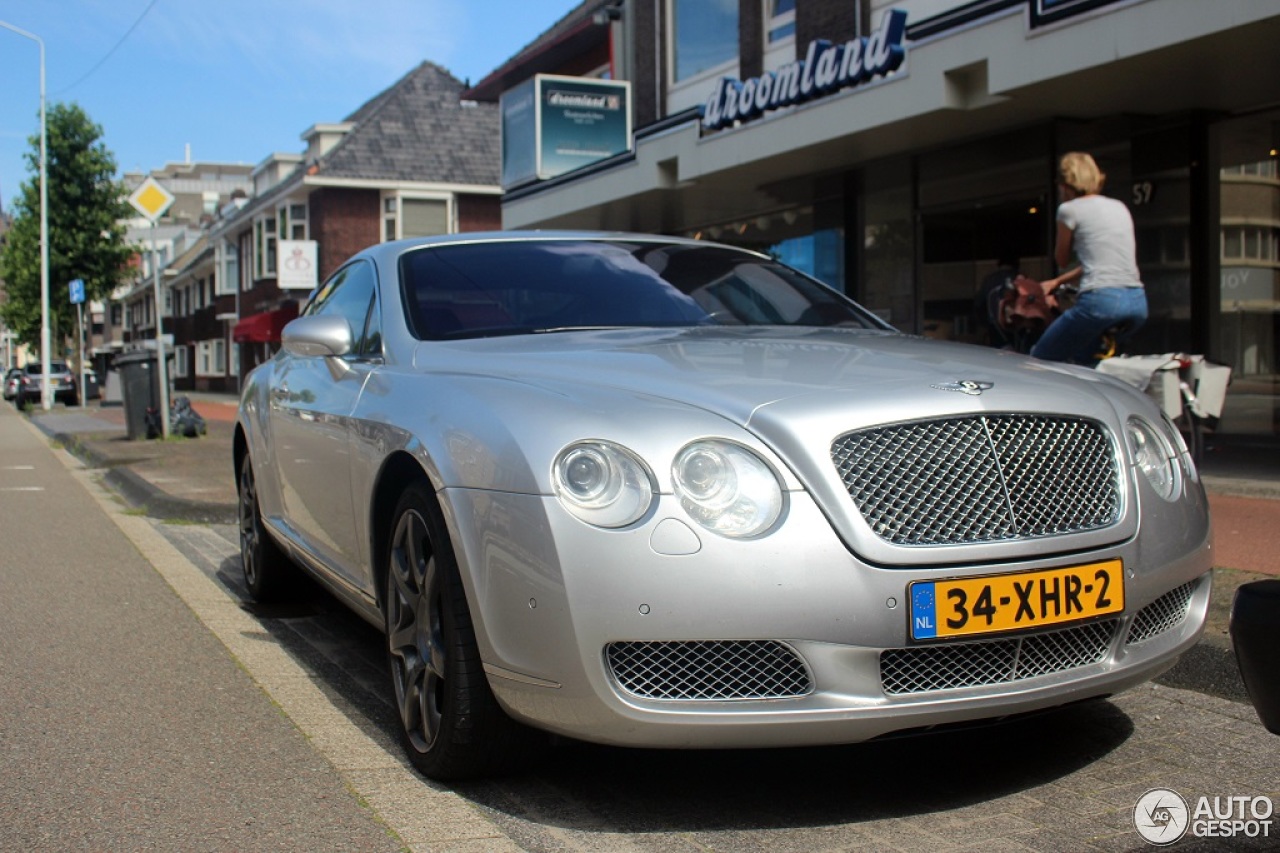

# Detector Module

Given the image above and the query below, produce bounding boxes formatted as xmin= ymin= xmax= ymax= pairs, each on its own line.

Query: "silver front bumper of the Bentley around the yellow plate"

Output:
xmin=449 ymin=492 xmax=1211 ymax=747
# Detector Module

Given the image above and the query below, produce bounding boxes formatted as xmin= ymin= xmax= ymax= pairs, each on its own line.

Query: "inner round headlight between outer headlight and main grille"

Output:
xmin=671 ymin=441 xmax=782 ymax=538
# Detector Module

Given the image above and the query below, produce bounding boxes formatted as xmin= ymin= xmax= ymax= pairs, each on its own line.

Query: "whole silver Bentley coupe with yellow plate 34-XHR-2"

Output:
xmin=234 ymin=232 xmax=1211 ymax=779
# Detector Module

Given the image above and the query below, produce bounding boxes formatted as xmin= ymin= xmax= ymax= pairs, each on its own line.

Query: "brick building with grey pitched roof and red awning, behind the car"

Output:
xmin=175 ymin=61 xmax=502 ymax=392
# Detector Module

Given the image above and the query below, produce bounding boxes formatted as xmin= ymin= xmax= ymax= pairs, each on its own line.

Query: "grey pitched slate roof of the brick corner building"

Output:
xmin=314 ymin=61 xmax=502 ymax=186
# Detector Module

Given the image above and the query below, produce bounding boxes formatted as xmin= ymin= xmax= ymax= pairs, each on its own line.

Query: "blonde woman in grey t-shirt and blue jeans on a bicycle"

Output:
xmin=1032 ymin=151 xmax=1147 ymax=366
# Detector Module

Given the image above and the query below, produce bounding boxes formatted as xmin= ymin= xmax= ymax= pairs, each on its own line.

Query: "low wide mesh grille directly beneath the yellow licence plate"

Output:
xmin=881 ymin=619 xmax=1120 ymax=695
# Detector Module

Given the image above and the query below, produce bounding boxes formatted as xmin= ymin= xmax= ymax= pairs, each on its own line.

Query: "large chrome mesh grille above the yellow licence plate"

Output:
xmin=831 ymin=415 xmax=1120 ymax=546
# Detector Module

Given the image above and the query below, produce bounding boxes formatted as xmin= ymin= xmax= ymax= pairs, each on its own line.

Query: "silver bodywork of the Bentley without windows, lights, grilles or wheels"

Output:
xmin=239 ymin=230 xmax=1211 ymax=747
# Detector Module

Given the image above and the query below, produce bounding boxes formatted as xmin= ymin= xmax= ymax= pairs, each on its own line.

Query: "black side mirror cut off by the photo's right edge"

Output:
xmin=1230 ymin=580 xmax=1280 ymax=735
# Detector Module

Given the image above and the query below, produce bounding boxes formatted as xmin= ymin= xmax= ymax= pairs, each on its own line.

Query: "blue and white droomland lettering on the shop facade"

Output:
xmin=703 ymin=9 xmax=906 ymax=131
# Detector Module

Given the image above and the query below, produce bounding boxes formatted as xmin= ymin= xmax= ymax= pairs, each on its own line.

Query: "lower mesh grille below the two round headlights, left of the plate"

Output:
xmin=605 ymin=640 xmax=813 ymax=699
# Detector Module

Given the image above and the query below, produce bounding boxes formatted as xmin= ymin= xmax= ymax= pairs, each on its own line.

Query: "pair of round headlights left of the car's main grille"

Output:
xmin=553 ymin=439 xmax=783 ymax=539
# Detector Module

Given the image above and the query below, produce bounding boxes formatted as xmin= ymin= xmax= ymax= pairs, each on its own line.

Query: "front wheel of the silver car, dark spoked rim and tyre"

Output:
xmin=383 ymin=483 xmax=547 ymax=780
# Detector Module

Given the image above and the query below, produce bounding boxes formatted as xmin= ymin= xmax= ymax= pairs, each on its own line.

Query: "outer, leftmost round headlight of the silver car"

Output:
xmin=552 ymin=441 xmax=654 ymax=528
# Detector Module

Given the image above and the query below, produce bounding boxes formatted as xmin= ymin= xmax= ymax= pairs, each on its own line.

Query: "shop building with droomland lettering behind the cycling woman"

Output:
xmin=468 ymin=0 xmax=1280 ymax=439
